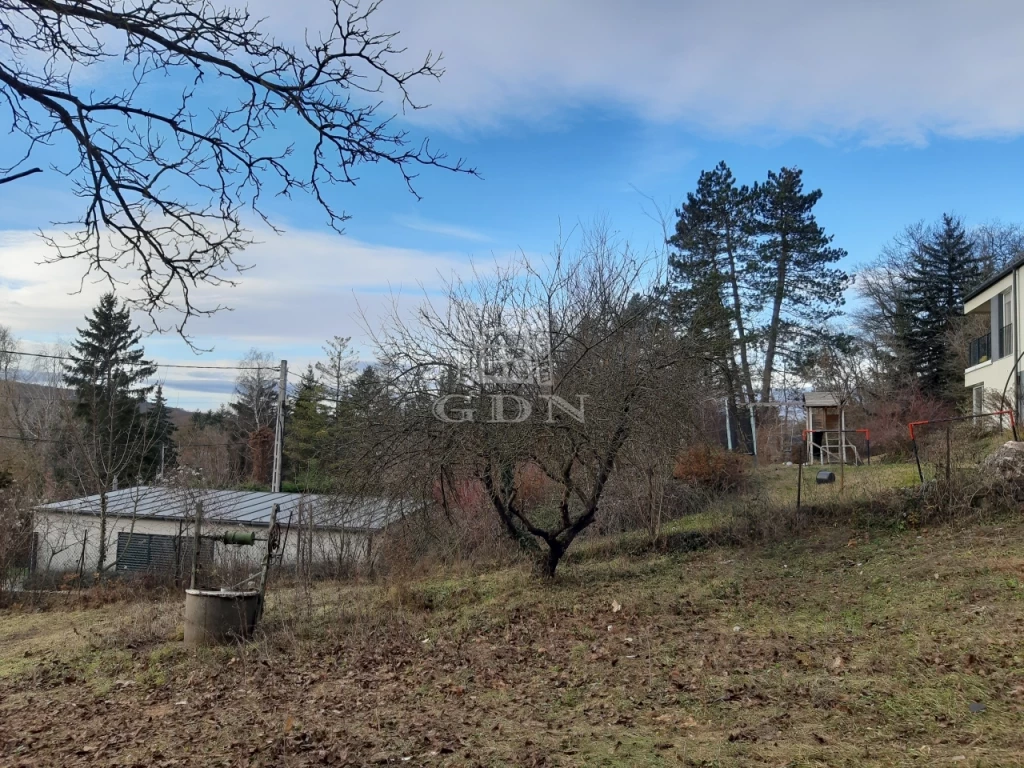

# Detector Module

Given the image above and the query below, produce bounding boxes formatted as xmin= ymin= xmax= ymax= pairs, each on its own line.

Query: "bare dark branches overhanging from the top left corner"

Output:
xmin=0 ymin=0 xmax=474 ymax=333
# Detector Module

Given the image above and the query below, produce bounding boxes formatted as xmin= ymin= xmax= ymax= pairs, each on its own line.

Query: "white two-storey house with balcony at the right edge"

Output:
xmin=964 ymin=259 xmax=1024 ymax=421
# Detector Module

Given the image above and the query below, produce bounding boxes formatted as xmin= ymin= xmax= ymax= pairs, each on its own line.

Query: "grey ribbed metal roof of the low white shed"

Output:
xmin=36 ymin=485 xmax=409 ymax=530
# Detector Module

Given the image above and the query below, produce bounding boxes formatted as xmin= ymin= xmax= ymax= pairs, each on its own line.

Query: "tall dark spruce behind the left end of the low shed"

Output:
xmin=63 ymin=293 xmax=157 ymax=574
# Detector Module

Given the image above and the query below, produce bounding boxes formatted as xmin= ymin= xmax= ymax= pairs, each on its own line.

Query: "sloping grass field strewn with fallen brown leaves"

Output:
xmin=0 ymin=495 xmax=1024 ymax=766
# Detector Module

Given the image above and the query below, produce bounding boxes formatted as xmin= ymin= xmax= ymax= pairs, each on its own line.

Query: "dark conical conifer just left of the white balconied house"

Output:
xmin=905 ymin=214 xmax=982 ymax=401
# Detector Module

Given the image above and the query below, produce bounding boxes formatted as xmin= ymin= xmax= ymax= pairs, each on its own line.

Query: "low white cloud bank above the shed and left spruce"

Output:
xmin=0 ymin=230 xmax=468 ymax=408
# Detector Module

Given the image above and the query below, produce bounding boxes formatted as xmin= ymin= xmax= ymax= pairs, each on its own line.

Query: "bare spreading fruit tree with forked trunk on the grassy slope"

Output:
xmin=367 ymin=227 xmax=696 ymax=577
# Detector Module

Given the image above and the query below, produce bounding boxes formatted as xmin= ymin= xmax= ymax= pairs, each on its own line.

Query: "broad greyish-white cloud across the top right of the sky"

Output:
xmin=250 ymin=0 xmax=1024 ymax=142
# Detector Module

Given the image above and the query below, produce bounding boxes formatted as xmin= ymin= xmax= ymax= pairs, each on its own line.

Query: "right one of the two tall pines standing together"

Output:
xmin=752 ymin=168 xmax=850 ymax=402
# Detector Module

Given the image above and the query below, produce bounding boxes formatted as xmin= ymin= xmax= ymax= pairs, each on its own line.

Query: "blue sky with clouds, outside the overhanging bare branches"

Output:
xmin=0 ymin=0 xmax=1024 ymax=408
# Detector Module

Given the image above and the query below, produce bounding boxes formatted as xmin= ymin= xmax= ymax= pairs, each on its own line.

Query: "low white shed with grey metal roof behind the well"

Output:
xmin=32 ymin=485 xmax=402 ymax=577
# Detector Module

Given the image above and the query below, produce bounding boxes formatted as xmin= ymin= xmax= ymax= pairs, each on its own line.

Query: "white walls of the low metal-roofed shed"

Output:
xmin=35 ymin=511 xmax=374 ymax=573
